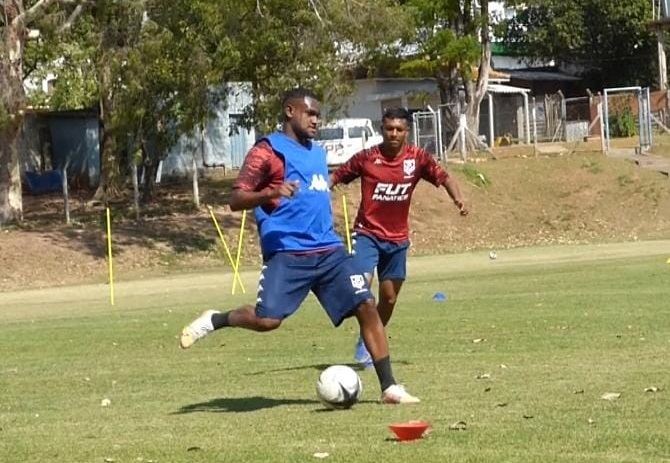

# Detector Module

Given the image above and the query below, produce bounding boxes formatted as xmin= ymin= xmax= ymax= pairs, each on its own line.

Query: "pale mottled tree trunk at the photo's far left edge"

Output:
xmin=0 ymin=0 xmax=25 ymax=228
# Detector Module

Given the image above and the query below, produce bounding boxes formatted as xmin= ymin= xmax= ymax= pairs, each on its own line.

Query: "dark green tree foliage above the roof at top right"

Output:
xmin=498 ymin=0 xmax=656 ymax=86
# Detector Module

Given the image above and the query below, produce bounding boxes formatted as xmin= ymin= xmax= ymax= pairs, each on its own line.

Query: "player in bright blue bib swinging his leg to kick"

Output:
xmin=180 ymin=88 xmax=419 ymax=404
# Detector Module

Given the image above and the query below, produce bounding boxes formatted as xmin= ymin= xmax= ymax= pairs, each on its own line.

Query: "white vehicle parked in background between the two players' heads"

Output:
xmin=314 ymin=118 xmax=382 ymax=166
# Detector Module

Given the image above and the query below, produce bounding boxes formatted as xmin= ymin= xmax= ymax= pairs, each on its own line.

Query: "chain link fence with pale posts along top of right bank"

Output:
xmin=412 ymin=88 xmax=670 ymax=160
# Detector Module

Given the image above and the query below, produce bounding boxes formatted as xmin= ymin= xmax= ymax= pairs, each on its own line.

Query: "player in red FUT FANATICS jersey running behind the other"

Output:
xmin=330 ymin=108 xmax=468 ymax=367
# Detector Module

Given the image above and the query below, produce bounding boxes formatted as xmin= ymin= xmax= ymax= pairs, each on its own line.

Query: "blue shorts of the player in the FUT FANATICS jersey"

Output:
xmin=354 ymin=233 xmax=409 ymax=281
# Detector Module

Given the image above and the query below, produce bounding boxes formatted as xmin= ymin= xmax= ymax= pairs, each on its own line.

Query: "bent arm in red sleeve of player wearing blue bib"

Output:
xmin=229 ymin=143 xmax=299 ymax=211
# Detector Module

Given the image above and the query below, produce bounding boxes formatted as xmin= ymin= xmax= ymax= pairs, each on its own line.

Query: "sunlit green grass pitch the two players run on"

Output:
xmin=0 ymin=241 xmax=670 ymax=463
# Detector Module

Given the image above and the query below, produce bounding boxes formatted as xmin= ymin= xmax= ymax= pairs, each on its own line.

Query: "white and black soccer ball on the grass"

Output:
xmin=316 ymin=365 xmax=363 ymax=409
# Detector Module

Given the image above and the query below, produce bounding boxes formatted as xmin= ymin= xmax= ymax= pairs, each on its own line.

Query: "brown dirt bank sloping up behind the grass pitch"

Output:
xmin=0 ymin=154 xmax=670 ymax=291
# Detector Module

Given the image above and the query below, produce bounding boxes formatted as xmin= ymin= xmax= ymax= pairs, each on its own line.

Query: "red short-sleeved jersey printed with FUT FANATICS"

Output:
xmin=332 ymin=144 xmax=449 ymax=242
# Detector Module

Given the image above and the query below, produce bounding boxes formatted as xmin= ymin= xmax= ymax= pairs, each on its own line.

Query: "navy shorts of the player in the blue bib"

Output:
xmin=256 ymin=247 xmax=373 ymax=326
